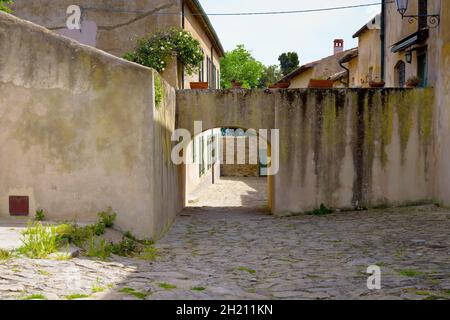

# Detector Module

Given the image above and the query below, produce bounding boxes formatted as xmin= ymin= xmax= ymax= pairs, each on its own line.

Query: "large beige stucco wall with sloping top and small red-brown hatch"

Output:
xmin=0 ymin=12 xmax=183 ymax=237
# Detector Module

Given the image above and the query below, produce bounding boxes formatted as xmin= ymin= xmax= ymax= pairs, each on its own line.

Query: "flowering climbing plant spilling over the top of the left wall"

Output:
xmin=124 ymin=28 xmax=205 ymax=75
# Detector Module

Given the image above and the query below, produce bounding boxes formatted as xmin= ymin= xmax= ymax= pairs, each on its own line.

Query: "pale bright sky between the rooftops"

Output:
xmin=200 ymin=0 xmax=381 ymax=65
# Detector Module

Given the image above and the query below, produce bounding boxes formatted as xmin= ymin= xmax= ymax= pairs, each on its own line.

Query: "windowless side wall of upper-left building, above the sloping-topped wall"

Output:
xmin=12 ymin=0 xmax=181 ymax=87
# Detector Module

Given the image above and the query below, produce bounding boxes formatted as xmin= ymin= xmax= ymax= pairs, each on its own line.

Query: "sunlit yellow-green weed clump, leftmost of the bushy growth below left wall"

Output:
xmin=18 ymin=221 xmax=60 ymax=259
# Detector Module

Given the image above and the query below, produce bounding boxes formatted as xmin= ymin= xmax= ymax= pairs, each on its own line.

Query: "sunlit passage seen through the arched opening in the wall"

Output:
xmin=184 ymin=127 xmax=270 ymax=211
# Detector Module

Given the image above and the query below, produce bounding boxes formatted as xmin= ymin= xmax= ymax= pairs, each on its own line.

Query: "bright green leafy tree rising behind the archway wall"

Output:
xmin=220 ymin=45 xmax=264 ymax=89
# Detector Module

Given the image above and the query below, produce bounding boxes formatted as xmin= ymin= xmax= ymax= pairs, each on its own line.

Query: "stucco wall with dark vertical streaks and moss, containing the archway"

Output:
xmin=177 ymin=89 xmax=434 ymax=214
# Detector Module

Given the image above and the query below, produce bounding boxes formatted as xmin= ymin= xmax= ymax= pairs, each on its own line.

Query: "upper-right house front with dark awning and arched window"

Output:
xmin=381 ymin=0 xmax=447 ymax=87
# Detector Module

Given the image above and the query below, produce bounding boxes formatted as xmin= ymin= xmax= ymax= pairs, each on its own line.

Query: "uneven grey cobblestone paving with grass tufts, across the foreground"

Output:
xmin=0 ymin=181 xmax=450 ymax=299
